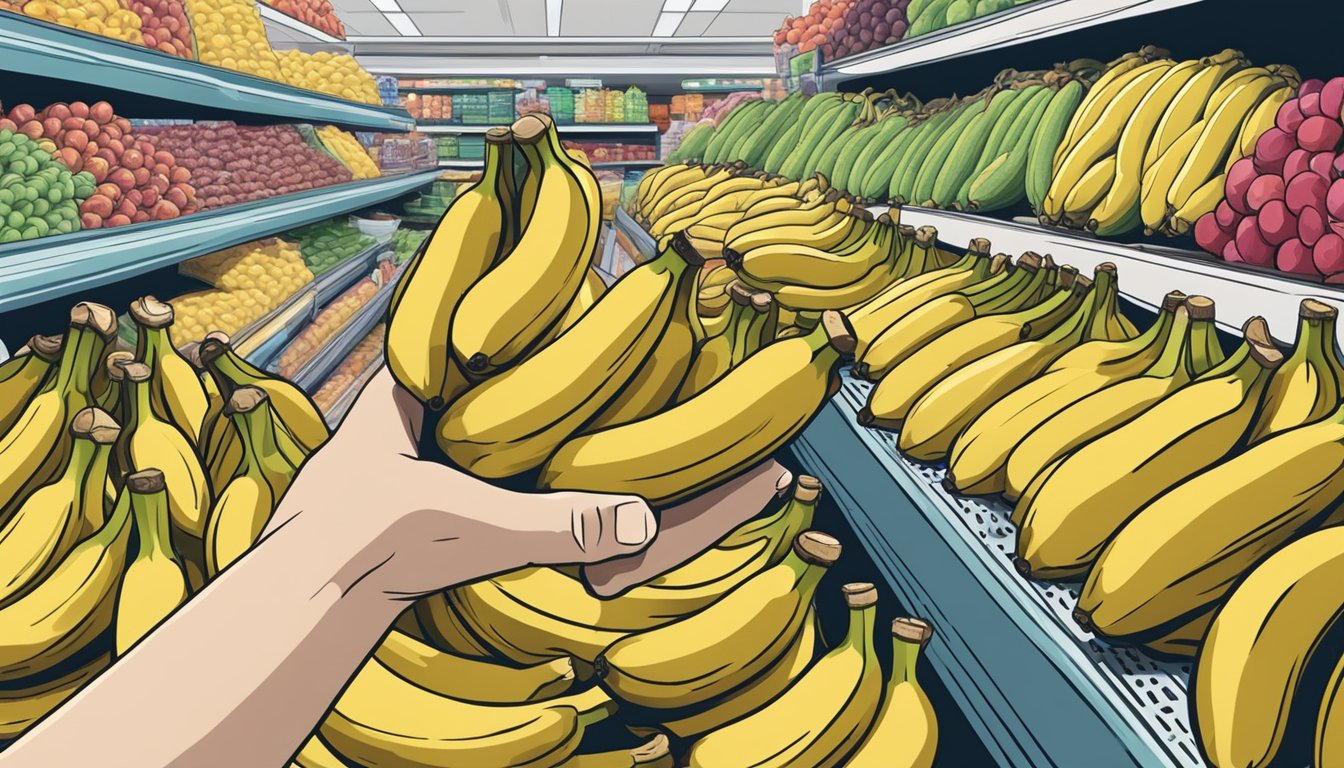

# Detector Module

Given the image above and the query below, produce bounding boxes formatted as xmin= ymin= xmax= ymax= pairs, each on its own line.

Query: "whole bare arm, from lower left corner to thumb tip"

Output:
xmin=0 ymin=370 xmax=656 ymax=768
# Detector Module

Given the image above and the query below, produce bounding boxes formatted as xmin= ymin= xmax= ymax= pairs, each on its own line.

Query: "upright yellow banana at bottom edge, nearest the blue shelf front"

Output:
xmin=845 ymin=619 xmax=938 ymax=768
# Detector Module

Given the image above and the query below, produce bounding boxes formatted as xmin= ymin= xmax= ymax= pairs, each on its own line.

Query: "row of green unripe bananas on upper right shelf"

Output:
xmin=669 ymin=59 xmax=1105 ymax=211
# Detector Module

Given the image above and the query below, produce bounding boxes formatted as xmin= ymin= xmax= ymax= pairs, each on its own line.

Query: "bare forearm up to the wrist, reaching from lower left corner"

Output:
xmin=0 ymin=505 xmax=398 ymax=768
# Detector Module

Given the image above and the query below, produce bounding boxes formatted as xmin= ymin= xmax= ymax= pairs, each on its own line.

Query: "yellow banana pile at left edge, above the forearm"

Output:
xmin=0 ymin=297 xmax=327 ymax=741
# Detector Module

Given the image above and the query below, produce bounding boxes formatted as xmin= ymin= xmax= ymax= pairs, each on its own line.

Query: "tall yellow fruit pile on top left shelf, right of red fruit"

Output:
xmin=187 ymin=0 xmax=284 ymax=82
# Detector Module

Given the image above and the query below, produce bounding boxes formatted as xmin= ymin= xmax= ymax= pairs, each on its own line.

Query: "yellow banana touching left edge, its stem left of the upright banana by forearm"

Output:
xmin=0 ymin=471 xmax=133 ymax=682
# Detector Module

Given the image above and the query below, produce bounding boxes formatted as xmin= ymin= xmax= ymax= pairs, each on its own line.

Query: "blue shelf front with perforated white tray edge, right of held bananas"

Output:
xmin=793 ymin=375 xmax=1203 ymax=768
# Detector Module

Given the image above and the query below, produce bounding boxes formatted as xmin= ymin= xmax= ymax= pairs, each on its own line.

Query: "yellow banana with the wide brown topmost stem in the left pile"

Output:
xmin=130 ymin=296 xmax=210 ymax=448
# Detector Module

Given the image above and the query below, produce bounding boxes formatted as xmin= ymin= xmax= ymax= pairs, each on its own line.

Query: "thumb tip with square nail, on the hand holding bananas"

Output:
xmin=518 ymin=492 xmax=659 ymax=565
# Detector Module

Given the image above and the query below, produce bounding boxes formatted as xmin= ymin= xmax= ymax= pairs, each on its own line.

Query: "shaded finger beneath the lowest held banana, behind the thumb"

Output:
xmin=583 ymin=460 xmax=793 ymax=597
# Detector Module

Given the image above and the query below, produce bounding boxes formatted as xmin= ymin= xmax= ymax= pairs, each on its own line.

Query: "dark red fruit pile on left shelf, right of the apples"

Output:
xmin=142 ymin=122 xmax=352 ymax=208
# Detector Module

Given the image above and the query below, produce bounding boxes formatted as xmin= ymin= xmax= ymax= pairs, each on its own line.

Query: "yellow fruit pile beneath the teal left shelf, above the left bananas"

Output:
xmin=171 ymin=239 xmax=313 ymax=347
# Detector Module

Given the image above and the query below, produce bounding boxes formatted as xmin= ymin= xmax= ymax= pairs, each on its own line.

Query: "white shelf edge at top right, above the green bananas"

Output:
xmin=821 ymin=0 xmax=1200 ymax=82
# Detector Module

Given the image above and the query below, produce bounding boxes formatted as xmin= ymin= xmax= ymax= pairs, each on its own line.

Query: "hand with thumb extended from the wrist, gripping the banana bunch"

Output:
xmin=262 ymin=369 xmax=657 ymax=601
